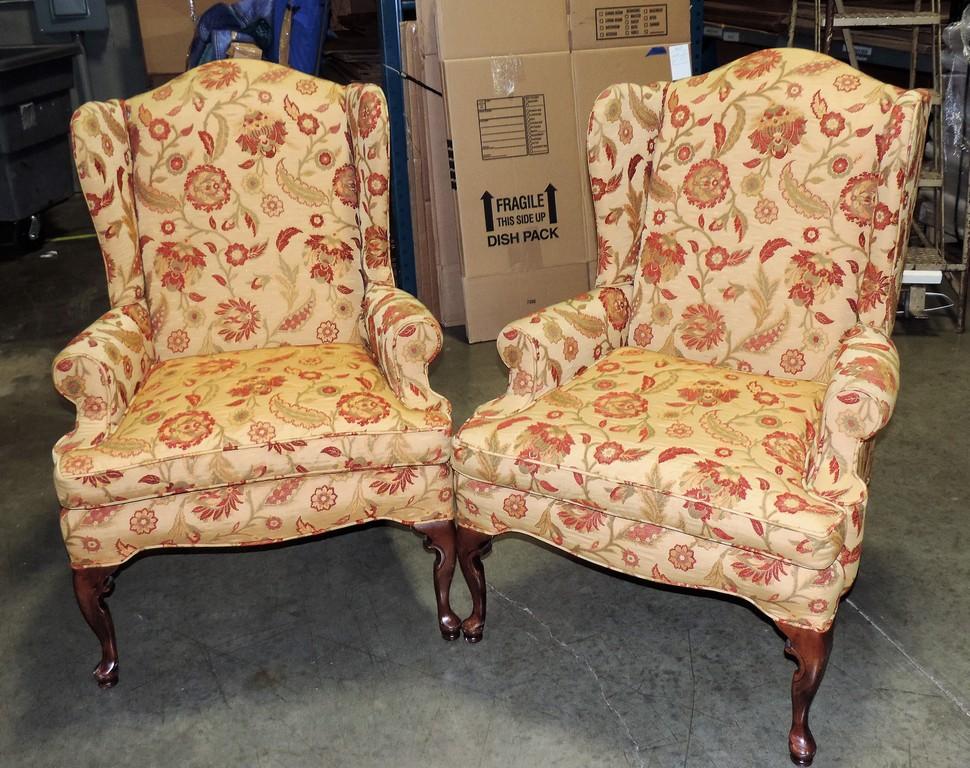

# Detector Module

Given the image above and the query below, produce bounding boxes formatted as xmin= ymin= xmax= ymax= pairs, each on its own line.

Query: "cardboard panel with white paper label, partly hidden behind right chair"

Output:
xmin=569 ymin=44 xmax=690 ymax=268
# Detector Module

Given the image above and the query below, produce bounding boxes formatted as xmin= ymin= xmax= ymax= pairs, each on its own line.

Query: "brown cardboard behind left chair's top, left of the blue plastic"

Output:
xmin=138 ymin=0 xmax=219 ymax=75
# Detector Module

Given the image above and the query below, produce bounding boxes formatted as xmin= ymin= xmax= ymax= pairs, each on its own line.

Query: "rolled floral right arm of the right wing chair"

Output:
xmin=808 ymin=323 xmax=899 ymax=507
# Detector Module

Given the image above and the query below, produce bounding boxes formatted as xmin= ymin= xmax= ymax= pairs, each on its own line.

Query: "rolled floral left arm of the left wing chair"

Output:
xmin=51 ymin=304 xmax=155 ymax=453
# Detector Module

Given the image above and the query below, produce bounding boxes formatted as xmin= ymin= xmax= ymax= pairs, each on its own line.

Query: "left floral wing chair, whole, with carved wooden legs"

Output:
xmin=53 ymin=60 xmax=459 ymax=685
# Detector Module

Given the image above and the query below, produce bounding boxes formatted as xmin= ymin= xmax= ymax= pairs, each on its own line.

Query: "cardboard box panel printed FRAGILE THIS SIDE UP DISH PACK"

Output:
xmin=444 ymin=52 xmax=588 ymax=282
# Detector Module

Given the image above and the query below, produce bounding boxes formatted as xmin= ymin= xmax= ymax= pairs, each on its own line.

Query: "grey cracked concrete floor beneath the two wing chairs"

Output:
xmin=0 ymin=201 xmax=970 ymax=768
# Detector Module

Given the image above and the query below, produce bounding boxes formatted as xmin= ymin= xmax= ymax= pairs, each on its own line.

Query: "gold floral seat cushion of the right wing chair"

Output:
xmin=453 ymin=347 xmax=845 ymax=568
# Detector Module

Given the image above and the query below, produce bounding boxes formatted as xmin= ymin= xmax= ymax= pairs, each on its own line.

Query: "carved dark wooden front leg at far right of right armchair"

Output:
xmin=778 ymin=622 xmax=832 ymax=766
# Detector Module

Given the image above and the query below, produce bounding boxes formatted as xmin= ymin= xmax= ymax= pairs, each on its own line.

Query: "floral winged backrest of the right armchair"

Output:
xmin=588 ymin=48 xmax=927 ymax=379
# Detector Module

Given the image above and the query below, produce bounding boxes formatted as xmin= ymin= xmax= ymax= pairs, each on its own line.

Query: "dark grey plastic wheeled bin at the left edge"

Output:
xmin=0 ymin=45 xmax=78 ymax=221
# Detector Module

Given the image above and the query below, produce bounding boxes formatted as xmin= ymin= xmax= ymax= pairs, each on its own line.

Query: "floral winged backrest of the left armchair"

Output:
xmin=72 ymin=60 xmax=393 ymax=358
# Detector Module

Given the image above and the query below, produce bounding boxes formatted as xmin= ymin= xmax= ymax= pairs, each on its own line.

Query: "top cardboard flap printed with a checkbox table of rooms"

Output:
xmin=569 ymin=0 xmax=690 ymax=51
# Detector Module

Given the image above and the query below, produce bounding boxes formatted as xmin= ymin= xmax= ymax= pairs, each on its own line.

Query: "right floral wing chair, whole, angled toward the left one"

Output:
xmin=452 ymin=49 xmax=926 ymax=765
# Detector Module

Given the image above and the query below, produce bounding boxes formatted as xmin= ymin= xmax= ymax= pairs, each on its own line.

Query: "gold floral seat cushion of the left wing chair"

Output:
xmin=54 ymin=344 xmax=451 ymax=508
